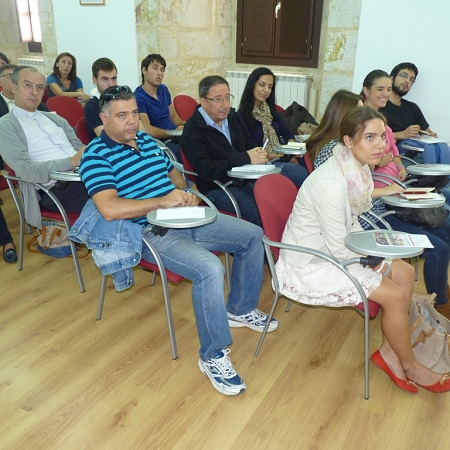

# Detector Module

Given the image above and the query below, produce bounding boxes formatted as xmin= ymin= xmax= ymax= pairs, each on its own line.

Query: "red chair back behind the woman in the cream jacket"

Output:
xmin=253 ymin=174 xmax=298 ymax=259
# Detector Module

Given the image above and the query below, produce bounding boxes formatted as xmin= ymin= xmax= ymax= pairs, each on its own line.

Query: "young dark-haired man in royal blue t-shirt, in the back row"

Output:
xmin=134 ymin=53 xmax=184 ymax=162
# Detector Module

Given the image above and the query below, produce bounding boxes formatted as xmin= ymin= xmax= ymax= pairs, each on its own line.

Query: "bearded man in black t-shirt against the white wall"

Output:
xmin=380 ymin=62 xmax=437 ymax=141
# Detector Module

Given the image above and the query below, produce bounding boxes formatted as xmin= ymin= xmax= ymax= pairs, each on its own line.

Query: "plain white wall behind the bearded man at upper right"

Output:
xmin=353 ymin=0 xmax=450 ymax=141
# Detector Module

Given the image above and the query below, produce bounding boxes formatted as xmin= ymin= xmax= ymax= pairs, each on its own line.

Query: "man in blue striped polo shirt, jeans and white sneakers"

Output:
xmin=80 ymin=86 xmax=278 ymax=395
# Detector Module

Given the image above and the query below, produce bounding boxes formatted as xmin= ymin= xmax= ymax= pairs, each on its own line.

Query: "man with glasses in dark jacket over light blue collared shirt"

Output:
xmin=181 ymin=75 xmax=267 ymax=226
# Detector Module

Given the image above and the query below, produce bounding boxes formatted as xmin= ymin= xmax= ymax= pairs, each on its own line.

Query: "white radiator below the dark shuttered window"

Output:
xmin=227 ymin=70 xmax=312 ymax=109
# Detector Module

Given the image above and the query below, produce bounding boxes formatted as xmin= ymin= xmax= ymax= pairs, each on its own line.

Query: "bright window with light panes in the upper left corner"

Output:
xmin=16 ymin=0 xmax=42 ymax=52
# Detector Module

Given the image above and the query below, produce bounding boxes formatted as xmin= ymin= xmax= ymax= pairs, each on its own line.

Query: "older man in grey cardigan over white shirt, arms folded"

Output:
xmin=0 ymin=66 xmax=88 ymax=228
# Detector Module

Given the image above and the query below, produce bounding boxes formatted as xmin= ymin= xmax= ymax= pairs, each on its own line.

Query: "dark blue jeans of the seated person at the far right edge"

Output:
xmin=385 ymin=215 xmax=450 ymax=305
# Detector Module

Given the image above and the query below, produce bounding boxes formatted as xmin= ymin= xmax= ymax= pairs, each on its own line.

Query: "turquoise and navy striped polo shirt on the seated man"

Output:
xmin=80 ymin=130 xmax=175 ymax=224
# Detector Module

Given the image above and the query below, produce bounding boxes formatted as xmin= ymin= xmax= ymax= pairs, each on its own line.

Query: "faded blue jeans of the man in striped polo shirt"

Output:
xmin=143 ymin=213 xmax=264 ymax=361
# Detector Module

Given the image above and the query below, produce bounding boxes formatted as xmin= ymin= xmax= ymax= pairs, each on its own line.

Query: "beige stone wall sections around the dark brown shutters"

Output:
xmin=34 ymin=0 xmax=361 ymax=118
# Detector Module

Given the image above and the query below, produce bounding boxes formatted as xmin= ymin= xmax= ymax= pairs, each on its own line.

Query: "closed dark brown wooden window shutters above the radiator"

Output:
xmin=236 ymin=0 xmax=323 ymax=67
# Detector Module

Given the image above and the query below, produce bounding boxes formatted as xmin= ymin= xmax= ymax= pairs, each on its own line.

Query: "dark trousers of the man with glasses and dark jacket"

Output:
xmin=206 ymin=181 xmax=262 ymax=227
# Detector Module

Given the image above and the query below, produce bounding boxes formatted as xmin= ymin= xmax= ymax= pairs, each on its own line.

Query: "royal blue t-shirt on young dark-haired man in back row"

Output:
xmin=134 ymin=84 xmax=177 ymax=130
